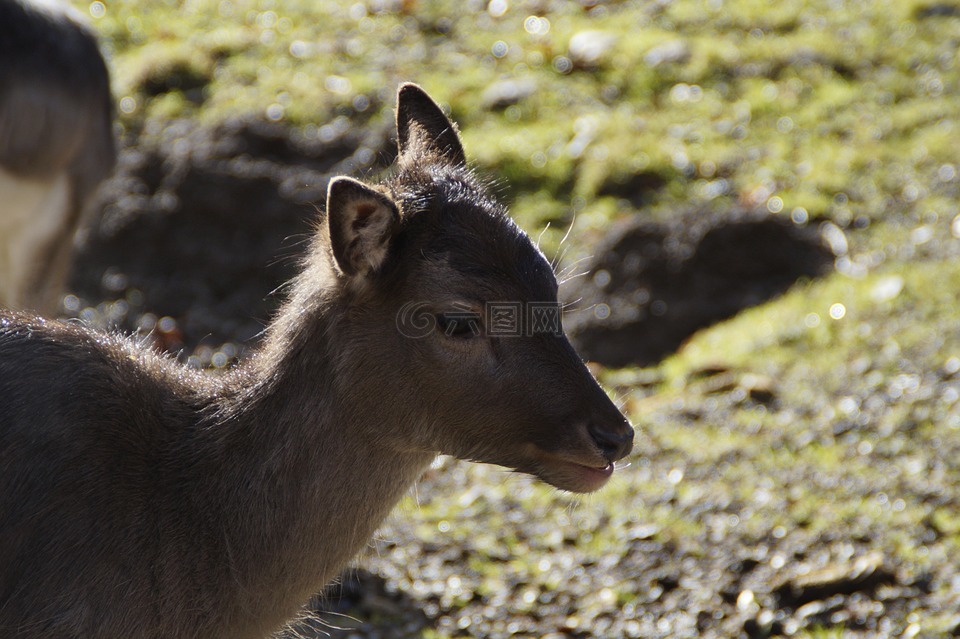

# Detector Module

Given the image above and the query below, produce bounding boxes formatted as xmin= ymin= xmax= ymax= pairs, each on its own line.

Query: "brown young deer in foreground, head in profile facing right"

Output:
xmin=0 ymin=84 xmax=633 ymax=639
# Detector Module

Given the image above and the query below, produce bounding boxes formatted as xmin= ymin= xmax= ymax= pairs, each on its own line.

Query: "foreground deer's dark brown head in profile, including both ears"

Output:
xmin=318 ymin=84 xmax=633 ymax=492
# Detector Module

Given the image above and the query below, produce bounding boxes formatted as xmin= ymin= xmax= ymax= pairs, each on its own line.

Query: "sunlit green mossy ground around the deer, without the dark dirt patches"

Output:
xmin=71 ymin=0 xmax=960 ymax=637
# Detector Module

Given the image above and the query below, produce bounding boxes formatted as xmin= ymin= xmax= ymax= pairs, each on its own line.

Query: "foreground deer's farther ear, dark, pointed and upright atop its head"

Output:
xmin=397 ymin=83 xmax=467 ymax=166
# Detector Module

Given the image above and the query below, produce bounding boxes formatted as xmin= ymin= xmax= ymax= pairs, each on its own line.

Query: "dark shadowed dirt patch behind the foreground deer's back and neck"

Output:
xmin=65 ymin=120 xmax=392 ymax=365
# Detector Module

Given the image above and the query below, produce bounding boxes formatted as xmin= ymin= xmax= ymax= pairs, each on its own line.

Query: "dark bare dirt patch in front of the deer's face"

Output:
xmin=562 ymin=209 xmax=834 ymax=366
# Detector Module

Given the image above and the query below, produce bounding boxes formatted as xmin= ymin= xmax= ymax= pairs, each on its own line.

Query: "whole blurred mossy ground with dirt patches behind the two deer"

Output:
xmin=43 ymin=0 xmax=960 ymax=639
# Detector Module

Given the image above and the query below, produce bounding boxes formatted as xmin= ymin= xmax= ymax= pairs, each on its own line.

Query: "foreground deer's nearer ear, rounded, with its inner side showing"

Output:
xmin=327 ymin=177 xmax=400 ymax=275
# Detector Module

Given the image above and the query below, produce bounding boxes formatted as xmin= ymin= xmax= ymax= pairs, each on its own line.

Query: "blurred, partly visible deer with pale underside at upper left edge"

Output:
xmin=0 ymin=0 xmax=117 ymax=316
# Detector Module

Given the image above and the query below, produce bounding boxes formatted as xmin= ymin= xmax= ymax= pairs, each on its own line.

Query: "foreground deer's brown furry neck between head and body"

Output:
xmin=204 ymin=270 xmax=434 ymax=615
